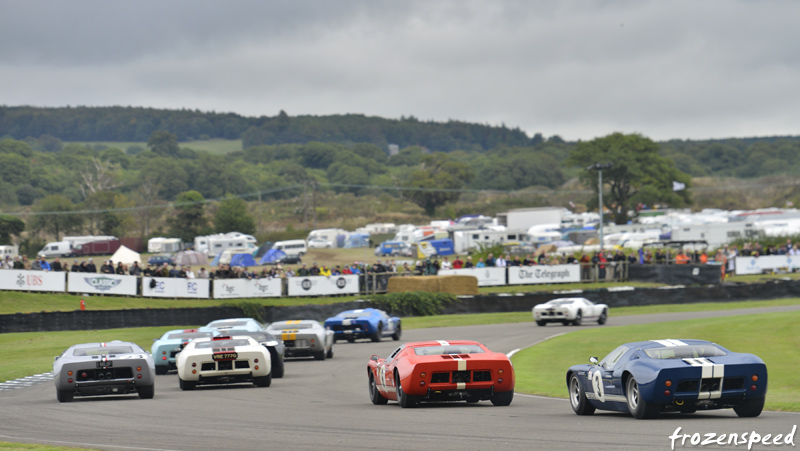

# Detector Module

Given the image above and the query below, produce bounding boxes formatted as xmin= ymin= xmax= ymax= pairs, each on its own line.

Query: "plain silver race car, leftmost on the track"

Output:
xmin=53 ymin=340 xmax=156 ymax=402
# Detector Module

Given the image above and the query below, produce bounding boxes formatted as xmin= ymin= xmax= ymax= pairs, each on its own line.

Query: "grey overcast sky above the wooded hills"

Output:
xmin=0 ymin=0 xmax=800 ymax=140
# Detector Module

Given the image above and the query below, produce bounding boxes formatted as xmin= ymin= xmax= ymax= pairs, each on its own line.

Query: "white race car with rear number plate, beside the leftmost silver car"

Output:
xmin=178 ymin=335 xmax=272 ymax=390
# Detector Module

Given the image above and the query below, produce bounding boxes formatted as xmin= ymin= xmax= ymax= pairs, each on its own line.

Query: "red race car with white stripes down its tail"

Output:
xmin=367 ymin=340 xmax=514 ymax=407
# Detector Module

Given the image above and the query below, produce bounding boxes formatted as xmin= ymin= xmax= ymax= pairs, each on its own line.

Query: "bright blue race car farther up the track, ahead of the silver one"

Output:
xmin=325 ymin=308 xmax=403 ymax=343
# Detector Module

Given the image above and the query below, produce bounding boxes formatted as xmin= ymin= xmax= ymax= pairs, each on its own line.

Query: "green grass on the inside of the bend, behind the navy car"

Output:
xmin=512 ymin=312 xmax=800 ymax=412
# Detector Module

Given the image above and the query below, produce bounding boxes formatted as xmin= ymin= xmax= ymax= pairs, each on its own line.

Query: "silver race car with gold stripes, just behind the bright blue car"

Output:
xmin=265 ymin=319 xmax=333 ymax=360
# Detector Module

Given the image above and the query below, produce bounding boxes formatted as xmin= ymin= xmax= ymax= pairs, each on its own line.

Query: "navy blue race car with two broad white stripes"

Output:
xmin=567 ymin=339 xmax=767 ymax=419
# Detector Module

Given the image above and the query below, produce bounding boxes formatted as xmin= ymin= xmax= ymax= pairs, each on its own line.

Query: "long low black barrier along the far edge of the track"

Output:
xmin=0 ymin=281 xmax=800 ymax=333
